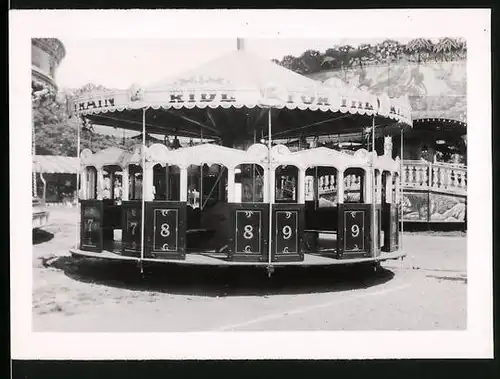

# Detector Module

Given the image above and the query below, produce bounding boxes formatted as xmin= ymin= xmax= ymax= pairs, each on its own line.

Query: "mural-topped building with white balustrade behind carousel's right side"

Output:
xmin=278 ymin=38 xmax=467 ymax=228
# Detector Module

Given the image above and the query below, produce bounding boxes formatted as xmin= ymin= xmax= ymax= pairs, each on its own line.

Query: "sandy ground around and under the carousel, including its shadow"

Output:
xmin=33 ymin=208 xmax=467 ymax=332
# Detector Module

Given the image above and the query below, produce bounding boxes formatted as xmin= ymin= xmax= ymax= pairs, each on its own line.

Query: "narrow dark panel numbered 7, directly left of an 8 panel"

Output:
xmin=122 ymin=200 xmax=142 ymax=256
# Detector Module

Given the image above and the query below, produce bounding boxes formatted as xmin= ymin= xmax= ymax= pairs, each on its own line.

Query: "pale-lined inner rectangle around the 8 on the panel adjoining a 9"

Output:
xmin=235 ymin=210 xmax=263 ymax=255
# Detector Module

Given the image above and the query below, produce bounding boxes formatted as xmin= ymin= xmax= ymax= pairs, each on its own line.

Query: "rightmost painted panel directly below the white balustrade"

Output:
xmin=430 ymin=193 xmax=466 ymax=222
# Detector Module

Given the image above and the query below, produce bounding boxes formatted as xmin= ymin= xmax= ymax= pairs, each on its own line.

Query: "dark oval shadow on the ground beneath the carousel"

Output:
xmin=44 ymin=257 xmax=394 ymax=297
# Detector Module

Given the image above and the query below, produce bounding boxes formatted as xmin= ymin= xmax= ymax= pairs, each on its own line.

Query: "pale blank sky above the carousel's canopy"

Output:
xmin=56 ymin=38 xmax=414 ymax=89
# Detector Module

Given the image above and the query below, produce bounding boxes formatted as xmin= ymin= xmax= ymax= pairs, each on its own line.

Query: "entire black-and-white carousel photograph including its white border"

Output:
xmin=10 ymin=10 xmax=493 ymax=359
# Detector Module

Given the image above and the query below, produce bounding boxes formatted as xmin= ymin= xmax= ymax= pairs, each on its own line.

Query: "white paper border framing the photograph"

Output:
xmin=9 ymin=9 xmax=493 ymax=360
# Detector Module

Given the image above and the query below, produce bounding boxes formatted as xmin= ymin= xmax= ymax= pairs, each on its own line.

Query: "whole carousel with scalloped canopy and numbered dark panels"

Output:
xmin=71 ymin=41 xmax=412 ymax=275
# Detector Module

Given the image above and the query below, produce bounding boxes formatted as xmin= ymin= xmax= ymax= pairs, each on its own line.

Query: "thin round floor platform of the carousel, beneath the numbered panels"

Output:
xmin=70 ymin=248 xmax=406 ymax=267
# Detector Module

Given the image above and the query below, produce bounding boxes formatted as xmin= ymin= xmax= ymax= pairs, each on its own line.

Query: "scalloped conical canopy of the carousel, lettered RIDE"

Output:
xmin=73 ymin=50 xmax=411 ymax=142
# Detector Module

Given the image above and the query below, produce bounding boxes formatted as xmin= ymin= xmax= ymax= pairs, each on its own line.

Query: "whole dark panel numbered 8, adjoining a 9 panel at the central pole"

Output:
xmin=228 ymin=203 xmax=269 ymax=262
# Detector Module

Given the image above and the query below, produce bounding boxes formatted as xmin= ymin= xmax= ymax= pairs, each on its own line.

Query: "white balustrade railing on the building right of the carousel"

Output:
xmin=402 ymin=160 xmax=467 ymax=196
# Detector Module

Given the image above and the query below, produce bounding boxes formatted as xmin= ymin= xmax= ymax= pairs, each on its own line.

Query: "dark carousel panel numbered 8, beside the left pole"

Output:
xmin=145 ymin=201 xmax=186 ymax=259
